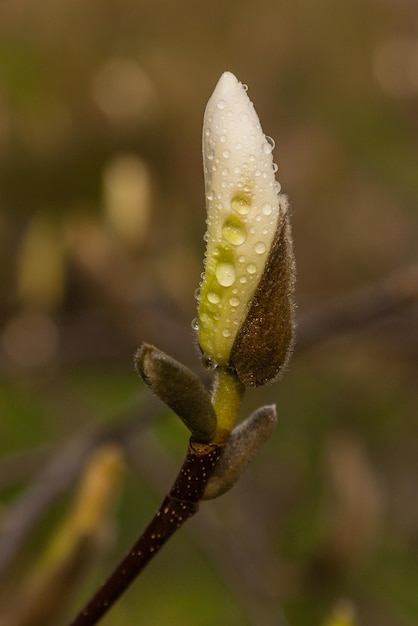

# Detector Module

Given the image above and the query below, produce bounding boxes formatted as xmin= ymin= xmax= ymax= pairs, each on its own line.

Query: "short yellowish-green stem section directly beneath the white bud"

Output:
xmin=212 ymin=367 xmax=245 ymax=443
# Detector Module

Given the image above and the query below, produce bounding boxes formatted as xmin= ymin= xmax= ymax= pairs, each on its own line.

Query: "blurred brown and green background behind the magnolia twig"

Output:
xmin=0 ymin=0 xmax=418 ymax=626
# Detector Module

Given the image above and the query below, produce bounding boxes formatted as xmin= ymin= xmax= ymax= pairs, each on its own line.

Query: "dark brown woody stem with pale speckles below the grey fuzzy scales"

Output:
xmin=69 ymin=440 xmax=222 ymax=626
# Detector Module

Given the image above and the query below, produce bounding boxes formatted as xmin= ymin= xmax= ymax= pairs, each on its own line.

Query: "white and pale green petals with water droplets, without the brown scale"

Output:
xmin=196 ymin=72 xmax=294 ymax=384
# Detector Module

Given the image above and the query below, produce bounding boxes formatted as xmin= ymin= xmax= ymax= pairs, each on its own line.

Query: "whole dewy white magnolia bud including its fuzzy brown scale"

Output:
xmin=196 ymin=72 xmax=294 ymax=386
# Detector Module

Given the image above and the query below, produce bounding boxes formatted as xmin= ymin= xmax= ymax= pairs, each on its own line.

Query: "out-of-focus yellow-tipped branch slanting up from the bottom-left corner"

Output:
xmin=0 ymin=444 xmax=123 ymax=626
